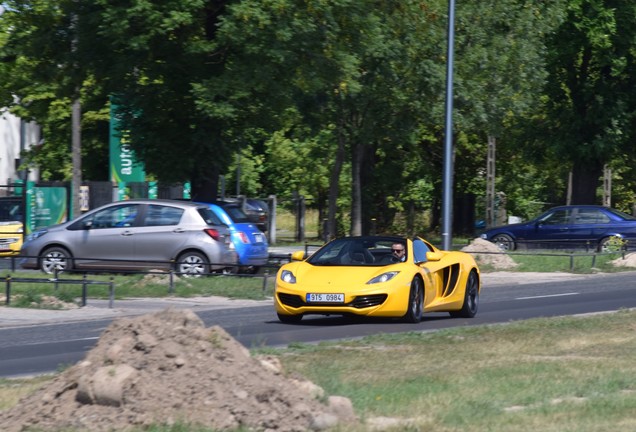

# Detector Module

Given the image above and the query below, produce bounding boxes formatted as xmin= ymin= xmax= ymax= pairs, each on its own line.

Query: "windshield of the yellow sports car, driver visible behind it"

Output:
xmin=307 ymin=237 xmax=405 ymax=266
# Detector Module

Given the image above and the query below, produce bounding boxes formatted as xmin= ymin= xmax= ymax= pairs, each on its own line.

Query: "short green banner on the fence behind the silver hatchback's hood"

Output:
xmin=25 ymin=182 xmax=68 ymax=234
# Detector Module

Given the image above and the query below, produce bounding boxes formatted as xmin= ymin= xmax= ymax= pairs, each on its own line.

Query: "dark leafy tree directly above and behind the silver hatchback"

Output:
xmin=82 ymin=0 xmax=231 ymax=201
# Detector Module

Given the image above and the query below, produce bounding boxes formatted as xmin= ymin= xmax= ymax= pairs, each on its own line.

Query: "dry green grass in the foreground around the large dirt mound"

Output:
xmin=0 ymin=311 xmax=636 ymax=432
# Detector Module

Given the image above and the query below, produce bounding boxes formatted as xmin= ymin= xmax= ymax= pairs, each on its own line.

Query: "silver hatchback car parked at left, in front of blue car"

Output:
xmin=20 ymin=199 xmax=238 ymax=275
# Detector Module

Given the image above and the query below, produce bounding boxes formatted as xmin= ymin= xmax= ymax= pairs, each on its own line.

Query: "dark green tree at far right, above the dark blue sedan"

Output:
xmin=535 ymin=0 xmax=636 ymax=204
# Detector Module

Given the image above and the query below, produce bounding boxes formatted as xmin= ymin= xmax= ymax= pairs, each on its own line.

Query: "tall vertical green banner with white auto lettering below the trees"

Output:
xmin=109 ymin=99 xmax=146 ymax=183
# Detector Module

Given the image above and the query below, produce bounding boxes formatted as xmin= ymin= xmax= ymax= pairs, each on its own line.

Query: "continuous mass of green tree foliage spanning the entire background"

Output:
xmin=0 ymin=0 xmax=636 ymax=236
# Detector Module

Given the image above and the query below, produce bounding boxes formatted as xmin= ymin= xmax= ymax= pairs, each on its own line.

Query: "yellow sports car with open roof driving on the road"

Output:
xmin=274 ymin=236 xmax=481 ymax=323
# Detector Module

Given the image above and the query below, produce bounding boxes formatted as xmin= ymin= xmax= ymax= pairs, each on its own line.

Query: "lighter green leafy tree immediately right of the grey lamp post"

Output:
xmin=455 ymin=0 xmax=562 ymax=228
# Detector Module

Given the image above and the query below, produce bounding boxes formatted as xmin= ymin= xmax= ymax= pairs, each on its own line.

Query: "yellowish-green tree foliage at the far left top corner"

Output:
xmin=0 ymin=0 xmax=108 ymax=180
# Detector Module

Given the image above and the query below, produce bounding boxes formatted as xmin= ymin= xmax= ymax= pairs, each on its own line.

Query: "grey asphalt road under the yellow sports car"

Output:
xmin=0 ymin=272 xmax=636 ymax=377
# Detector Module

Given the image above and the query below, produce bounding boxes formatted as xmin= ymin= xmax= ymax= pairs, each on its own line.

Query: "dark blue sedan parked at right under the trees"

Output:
xmin=480 ymin=205 xmax=636 ymax=251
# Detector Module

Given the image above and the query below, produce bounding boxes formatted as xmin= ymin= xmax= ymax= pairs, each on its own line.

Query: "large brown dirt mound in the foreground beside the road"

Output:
xmin=0 ymin=309 xmax=355 ymax=432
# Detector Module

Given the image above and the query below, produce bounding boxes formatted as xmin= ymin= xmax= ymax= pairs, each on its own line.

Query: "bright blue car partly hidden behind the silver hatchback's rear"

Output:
xmin=208 ymin=203 xmax=269 ymax=273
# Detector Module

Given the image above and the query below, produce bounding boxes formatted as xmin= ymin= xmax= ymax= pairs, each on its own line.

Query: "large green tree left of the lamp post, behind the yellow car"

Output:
xmin=205 ymin=0 xmax=452 ymax=235
